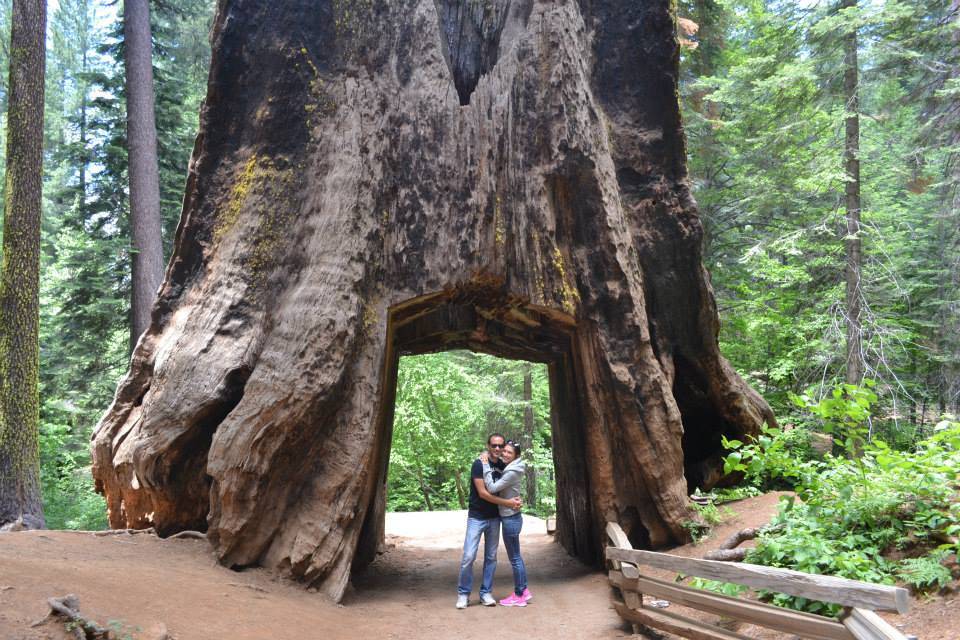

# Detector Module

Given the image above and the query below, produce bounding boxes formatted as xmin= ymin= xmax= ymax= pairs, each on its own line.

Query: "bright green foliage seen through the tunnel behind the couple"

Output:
xmin=387 ymin=350 xmax=556 ymax=516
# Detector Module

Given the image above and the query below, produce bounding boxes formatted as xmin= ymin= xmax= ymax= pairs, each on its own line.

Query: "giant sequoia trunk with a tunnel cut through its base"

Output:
xmin=93 ymin=0 xmax=771 ymax=598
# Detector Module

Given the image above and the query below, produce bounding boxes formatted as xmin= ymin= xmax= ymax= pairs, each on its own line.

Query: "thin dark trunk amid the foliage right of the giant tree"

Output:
xmin=842 ymin=0 xmax=864 ymax=384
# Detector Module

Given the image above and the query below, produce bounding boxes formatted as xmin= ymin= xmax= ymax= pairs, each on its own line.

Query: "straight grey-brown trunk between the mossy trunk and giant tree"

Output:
xmin=123 ymin=0 xmax=163 ymax=351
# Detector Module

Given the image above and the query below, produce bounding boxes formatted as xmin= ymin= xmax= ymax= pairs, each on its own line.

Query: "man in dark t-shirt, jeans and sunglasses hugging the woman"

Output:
xmin=457 ymin=433 xmax=521 ymax=609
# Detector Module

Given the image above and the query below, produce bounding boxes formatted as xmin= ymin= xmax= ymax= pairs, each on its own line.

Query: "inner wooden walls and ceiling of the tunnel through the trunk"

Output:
xmin=354 ymin=291 xmax=600 ymax=567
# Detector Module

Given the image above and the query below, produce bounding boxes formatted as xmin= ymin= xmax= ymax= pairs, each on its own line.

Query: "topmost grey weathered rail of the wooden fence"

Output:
xmin=607 ymin=547 xmax=909 ymax=613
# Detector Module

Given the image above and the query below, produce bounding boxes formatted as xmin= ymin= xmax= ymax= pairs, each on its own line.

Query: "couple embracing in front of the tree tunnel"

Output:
xmin=457 ymin=433 xmax=533 ymax=609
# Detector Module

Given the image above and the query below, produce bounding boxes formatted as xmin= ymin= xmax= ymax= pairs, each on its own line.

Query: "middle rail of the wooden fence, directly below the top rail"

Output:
xmin=610 ymin=571 xmax=853 ymax=640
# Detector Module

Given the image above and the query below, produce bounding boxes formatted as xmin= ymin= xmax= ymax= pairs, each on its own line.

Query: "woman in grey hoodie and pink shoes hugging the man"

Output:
xmin=480 ymin=440 xmax=533 ymax=607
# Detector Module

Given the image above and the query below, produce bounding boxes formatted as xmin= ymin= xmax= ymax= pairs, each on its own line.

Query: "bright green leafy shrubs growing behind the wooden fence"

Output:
xmin=725 ymin=385 xmax=960 ymax=615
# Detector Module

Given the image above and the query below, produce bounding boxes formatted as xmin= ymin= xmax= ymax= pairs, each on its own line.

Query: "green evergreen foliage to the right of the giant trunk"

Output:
xmin=681 ymin=0 xmax=960 ymax=432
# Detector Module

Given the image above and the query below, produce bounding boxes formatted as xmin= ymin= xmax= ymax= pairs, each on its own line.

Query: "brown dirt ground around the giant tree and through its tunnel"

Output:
xmin=0 ymin=494 xmax=960 ymax=640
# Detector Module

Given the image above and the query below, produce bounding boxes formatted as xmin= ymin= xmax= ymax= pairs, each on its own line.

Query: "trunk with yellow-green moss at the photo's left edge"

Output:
xmin=0 ymin=0 xmax=47 ymax=529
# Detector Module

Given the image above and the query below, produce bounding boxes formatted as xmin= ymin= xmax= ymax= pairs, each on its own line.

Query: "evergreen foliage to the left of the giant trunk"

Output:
xmin=32 ymin=0 xmax=213 ymax=528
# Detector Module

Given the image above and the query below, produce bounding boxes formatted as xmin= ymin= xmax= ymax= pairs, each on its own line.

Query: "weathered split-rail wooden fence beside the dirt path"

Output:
xmin=607 ymin=522 xmax=909 ymax=640
